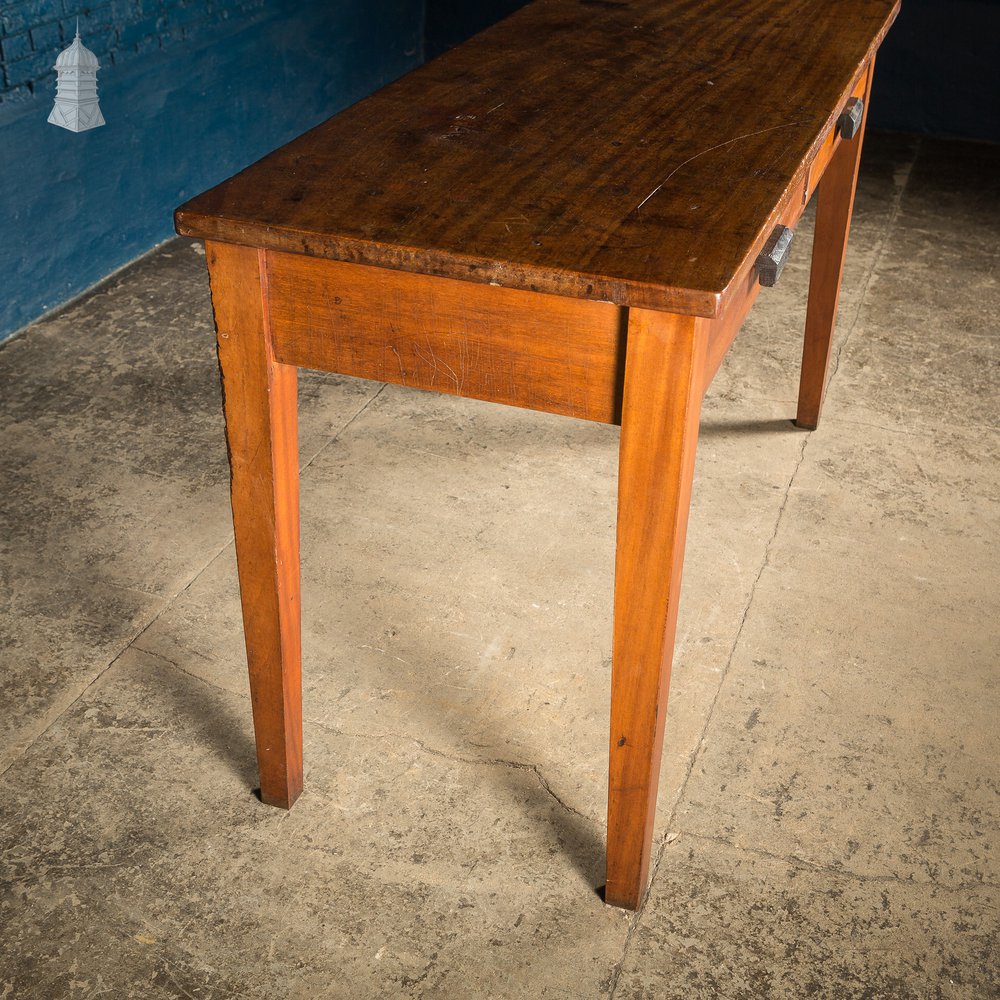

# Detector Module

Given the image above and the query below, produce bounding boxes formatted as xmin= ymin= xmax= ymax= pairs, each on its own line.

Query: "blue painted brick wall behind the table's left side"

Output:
xmin=0 ymin=0 xmax=423 ymax=339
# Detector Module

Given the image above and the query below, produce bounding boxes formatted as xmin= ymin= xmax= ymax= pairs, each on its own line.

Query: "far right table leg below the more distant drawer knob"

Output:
xmin=795 ymin=69 xmax=871 ymax=430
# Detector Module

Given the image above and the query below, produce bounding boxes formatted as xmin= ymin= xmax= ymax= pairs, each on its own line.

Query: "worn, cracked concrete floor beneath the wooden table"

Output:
xmin=0 ymin=135 xmax=1000 ymax=1000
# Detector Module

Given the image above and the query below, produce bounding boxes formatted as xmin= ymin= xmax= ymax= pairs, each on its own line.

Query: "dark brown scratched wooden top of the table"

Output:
xmin=176 ymin=0 xmax=899 ymax=317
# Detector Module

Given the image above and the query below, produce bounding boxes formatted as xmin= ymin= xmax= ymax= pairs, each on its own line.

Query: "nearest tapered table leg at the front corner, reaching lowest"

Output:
xmin=605 ymin=309 xmax=708 ymax=910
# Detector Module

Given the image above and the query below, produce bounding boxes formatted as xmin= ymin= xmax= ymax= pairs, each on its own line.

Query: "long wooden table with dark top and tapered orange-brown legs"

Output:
xmin=176 ymin=0 xmax=898 ymax=908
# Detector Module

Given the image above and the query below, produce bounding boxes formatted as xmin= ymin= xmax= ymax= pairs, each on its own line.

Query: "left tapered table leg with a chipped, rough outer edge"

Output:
xmin=206 ymin=243 xmax=302 ymax=809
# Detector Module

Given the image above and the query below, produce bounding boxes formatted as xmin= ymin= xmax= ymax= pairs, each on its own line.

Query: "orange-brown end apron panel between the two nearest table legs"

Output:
xmin=266 ymin=251 xmax=625 ymax=423
